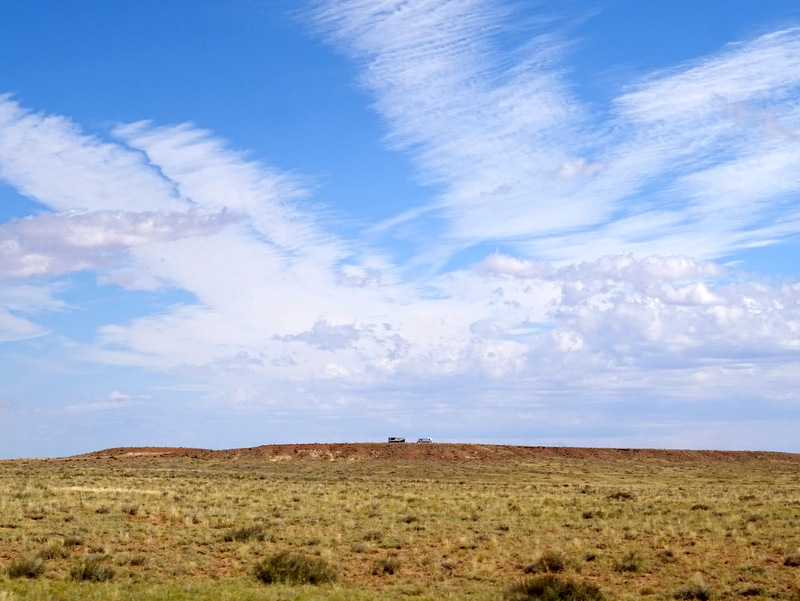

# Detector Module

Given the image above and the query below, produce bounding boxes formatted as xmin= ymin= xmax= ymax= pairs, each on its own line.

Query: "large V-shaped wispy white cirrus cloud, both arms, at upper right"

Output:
xmin=310 ymin=0 xmax=800 ymax=261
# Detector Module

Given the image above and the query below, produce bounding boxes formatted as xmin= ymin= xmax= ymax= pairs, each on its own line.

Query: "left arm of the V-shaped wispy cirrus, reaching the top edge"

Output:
xmin=317 ymin=0 xmax=592 ymax=246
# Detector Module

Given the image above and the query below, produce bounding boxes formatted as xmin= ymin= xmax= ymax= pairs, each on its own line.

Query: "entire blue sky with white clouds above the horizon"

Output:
xmin=0 ymin=0 xmax=800 ymax=458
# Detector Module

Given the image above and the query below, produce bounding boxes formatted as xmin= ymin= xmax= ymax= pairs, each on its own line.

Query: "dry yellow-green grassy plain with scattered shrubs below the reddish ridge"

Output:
xmin=0 ymin=445 xmax=800 ymax=601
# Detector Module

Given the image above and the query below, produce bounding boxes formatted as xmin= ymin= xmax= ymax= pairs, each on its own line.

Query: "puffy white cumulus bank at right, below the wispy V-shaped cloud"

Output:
xmin=477 ymin=255 xmax=800 ymax=373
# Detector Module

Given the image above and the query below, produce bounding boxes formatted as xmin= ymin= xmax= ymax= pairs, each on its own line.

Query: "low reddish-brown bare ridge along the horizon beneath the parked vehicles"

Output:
xmin=64 ymin=442 xmax=800 ymax=463
